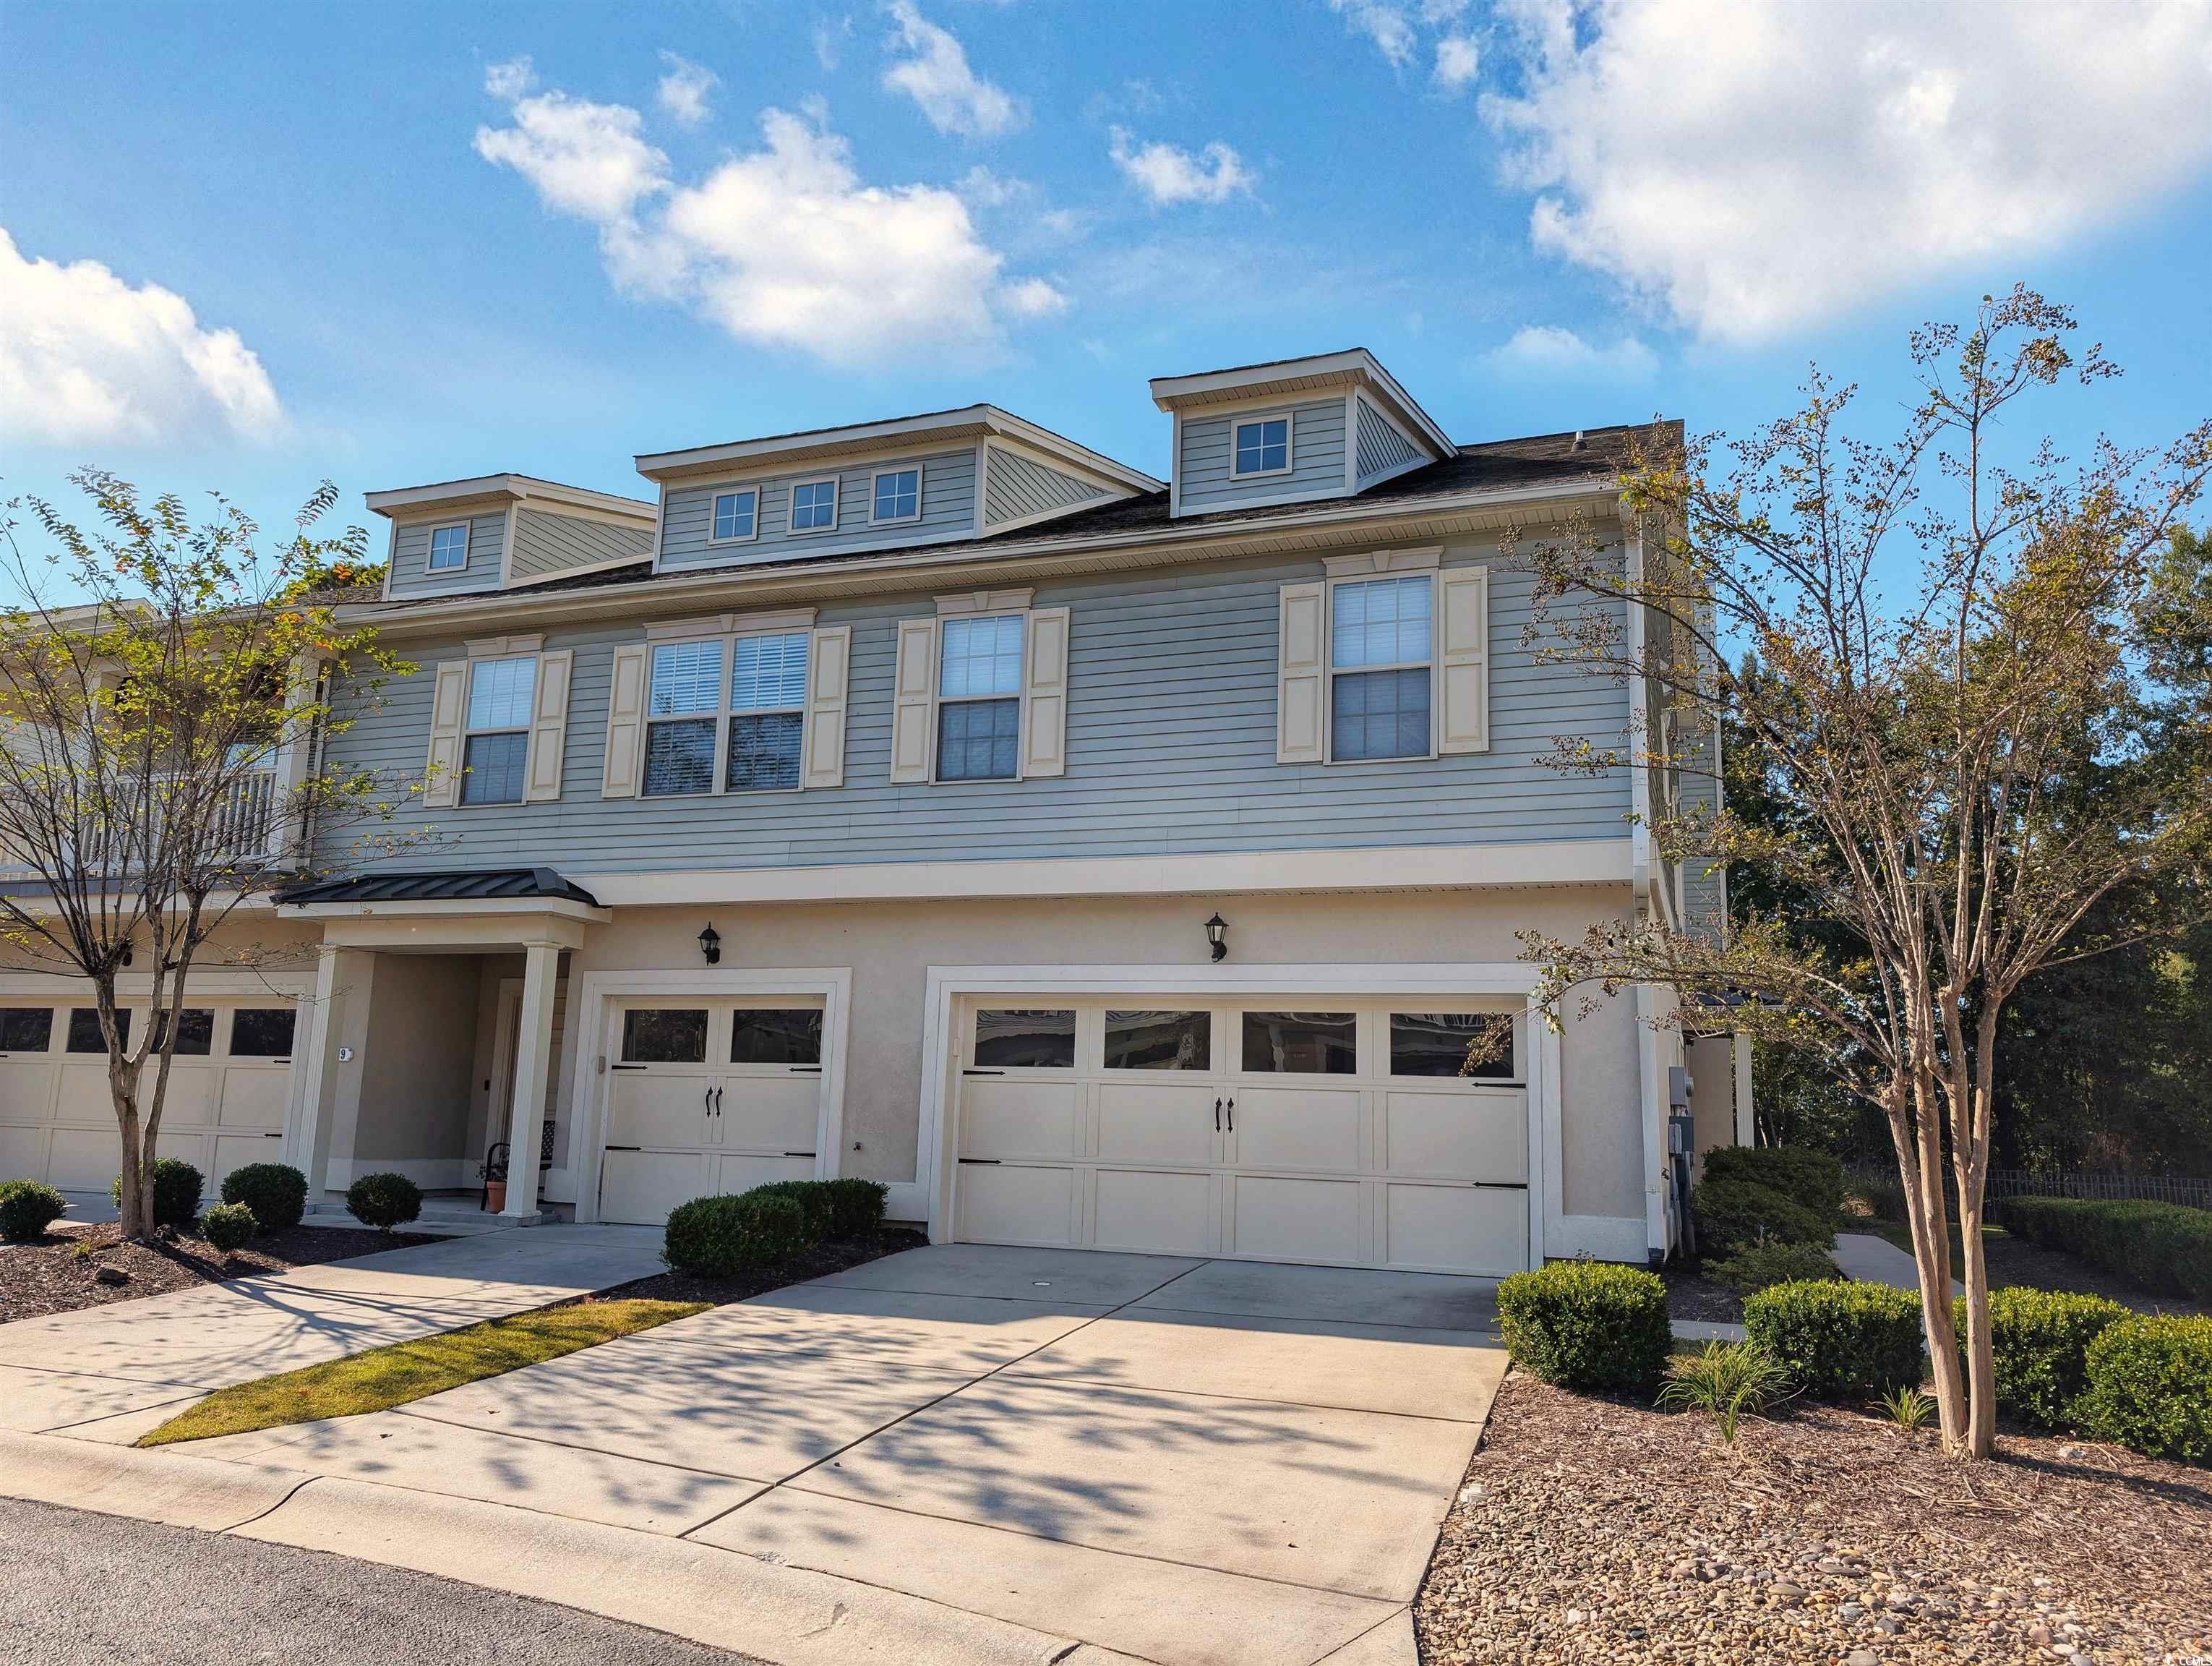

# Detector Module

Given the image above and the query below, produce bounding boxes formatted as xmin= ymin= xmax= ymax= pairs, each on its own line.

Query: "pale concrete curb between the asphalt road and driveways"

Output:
xmin=0 ymin=1432 xmax=1139 ymax=1666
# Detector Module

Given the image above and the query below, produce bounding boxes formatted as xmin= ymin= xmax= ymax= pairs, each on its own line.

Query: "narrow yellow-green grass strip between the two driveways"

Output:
xmin=140 ymin=1301 xmax=708 ymax=1447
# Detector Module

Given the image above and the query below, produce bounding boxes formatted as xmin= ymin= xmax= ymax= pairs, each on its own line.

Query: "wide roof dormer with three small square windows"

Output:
xmin=637 ymin=405 xmax=1159 ymax=573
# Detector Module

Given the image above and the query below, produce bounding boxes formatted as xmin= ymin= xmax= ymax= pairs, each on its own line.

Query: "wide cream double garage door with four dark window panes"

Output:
xmin=953 ymin=994 xmax=1528 ymax=1274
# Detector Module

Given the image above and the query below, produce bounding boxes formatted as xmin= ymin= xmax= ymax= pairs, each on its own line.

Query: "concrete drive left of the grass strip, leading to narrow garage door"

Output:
xmin=0 ymin=1226 xmax=661 ymax=1445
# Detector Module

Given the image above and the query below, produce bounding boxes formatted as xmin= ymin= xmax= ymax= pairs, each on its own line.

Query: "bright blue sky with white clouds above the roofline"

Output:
xmin=0 ymin=0 xmax=2212 ymax=566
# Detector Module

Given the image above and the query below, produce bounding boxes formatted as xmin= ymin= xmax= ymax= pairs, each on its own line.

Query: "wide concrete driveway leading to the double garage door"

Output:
xmin=173 ymin=1246 xmax=1504 ymax=1666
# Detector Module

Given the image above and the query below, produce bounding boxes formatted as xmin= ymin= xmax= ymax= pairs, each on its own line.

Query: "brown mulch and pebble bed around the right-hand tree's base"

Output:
xmin=1413 ymin=1370 xmax=2212 ymax=1666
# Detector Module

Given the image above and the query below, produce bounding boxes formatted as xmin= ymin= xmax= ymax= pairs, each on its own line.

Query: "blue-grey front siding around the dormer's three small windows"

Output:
xmin=661 ymin=449 xmax=975 ymax=568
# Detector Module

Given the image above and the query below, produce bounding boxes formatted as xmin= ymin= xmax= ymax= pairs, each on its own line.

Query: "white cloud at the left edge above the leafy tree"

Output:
xmin=0 ymin=228 xmax=286 ymax=445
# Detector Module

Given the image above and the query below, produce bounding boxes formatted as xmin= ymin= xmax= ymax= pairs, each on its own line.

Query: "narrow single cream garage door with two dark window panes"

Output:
xmin=599 ymin=998 xmax=823 ymax=1226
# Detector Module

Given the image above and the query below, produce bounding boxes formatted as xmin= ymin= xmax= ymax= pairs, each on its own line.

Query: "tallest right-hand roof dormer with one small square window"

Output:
xmin=1152 ymin=347 xmax=1458 ymax=516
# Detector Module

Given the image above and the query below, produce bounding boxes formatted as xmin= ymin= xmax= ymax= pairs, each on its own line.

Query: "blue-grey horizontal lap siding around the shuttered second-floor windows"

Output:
xmin=332 ymin=548 xmax=1628 ymax=874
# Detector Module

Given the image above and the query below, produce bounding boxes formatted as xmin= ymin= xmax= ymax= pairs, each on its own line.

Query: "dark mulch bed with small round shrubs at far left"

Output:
xmin=0 ymin=1221 xmax=436 ymax=1323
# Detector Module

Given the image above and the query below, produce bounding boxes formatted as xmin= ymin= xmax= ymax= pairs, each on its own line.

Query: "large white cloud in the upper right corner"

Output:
xmin=1484 ymin=0 xmax=2212 ymax=341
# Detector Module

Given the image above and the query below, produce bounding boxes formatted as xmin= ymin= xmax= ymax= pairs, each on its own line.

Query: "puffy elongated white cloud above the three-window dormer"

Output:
xmin=476 ymin=74 xmax=1066 ymax=365
